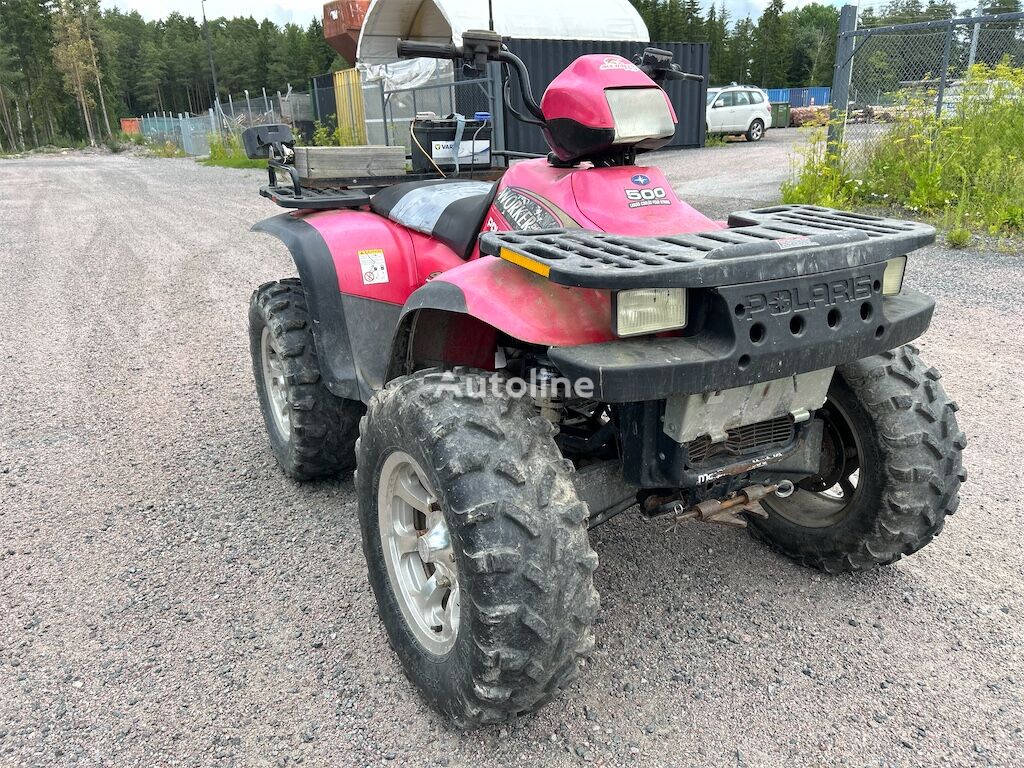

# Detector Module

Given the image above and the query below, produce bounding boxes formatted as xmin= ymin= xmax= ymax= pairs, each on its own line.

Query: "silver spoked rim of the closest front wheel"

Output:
xmin=377 ymin=451 xmax=460 ymax=655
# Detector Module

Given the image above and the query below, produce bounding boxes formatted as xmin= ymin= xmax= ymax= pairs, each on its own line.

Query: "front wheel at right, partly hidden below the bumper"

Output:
xmin=750 ymin=345 xmax=967 ymax=572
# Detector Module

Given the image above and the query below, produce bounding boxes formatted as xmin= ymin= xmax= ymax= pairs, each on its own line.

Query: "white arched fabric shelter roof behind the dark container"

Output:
xmin=356 ymin=0 xmax=650 ymax=65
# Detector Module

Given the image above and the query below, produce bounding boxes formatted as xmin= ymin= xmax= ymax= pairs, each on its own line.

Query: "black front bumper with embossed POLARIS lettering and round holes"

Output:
xmin=548 ymin=262 xmax=935 ymax=402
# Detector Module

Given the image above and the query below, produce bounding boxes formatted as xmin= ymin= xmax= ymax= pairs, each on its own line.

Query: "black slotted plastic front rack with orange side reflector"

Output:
xmin=480 ymin=205 xmax=935 ymax=289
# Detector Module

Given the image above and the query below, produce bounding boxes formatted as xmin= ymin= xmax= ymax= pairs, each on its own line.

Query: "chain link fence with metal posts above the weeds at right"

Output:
xmin=831 ymin=9 xmax=1024 ymax=166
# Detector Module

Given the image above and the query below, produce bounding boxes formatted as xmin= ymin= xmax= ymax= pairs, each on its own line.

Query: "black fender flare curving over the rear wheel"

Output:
xmin=252 ymin=213 xmax=362 ymax=400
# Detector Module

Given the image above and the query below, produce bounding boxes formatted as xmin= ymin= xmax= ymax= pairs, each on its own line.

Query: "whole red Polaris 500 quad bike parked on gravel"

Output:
xmin=245 ymin=32 xmax=965 ymax=727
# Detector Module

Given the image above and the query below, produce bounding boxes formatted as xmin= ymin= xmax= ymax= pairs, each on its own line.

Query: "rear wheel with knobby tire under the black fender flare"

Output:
xmin=249 ymin=278 xmax=366 ymax=480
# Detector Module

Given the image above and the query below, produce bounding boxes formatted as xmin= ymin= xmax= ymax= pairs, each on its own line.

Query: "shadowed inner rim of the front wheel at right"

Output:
xmin=762 ymin=399 xmax=864 ymax=528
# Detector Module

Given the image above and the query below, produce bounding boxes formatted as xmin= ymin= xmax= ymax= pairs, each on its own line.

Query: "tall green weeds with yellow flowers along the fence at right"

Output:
xmin=782 ymin=63 xmax=1024 ymax=239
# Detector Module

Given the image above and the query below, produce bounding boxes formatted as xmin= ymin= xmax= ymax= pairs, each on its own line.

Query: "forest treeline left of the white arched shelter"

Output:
xmin=0 ymin=0 xmax=347 ymax=152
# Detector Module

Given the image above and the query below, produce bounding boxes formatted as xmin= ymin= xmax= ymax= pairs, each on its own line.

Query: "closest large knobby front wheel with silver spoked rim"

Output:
xmin=355 ymin=371 xmax=599 ymax=727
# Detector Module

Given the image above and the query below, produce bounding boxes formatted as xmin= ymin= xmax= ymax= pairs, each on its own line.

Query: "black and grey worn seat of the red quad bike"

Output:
xmin=370 ymin=179 xmax=498 ymax=259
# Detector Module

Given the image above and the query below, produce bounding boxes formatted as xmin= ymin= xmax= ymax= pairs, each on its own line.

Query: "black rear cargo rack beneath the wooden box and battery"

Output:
xmin=259 ymin=160 xmax=505 ymax=211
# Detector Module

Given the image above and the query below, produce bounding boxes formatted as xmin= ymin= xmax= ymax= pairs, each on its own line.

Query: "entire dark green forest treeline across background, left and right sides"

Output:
xmin=0 ymin=0 xmax=1021 ymax=152
